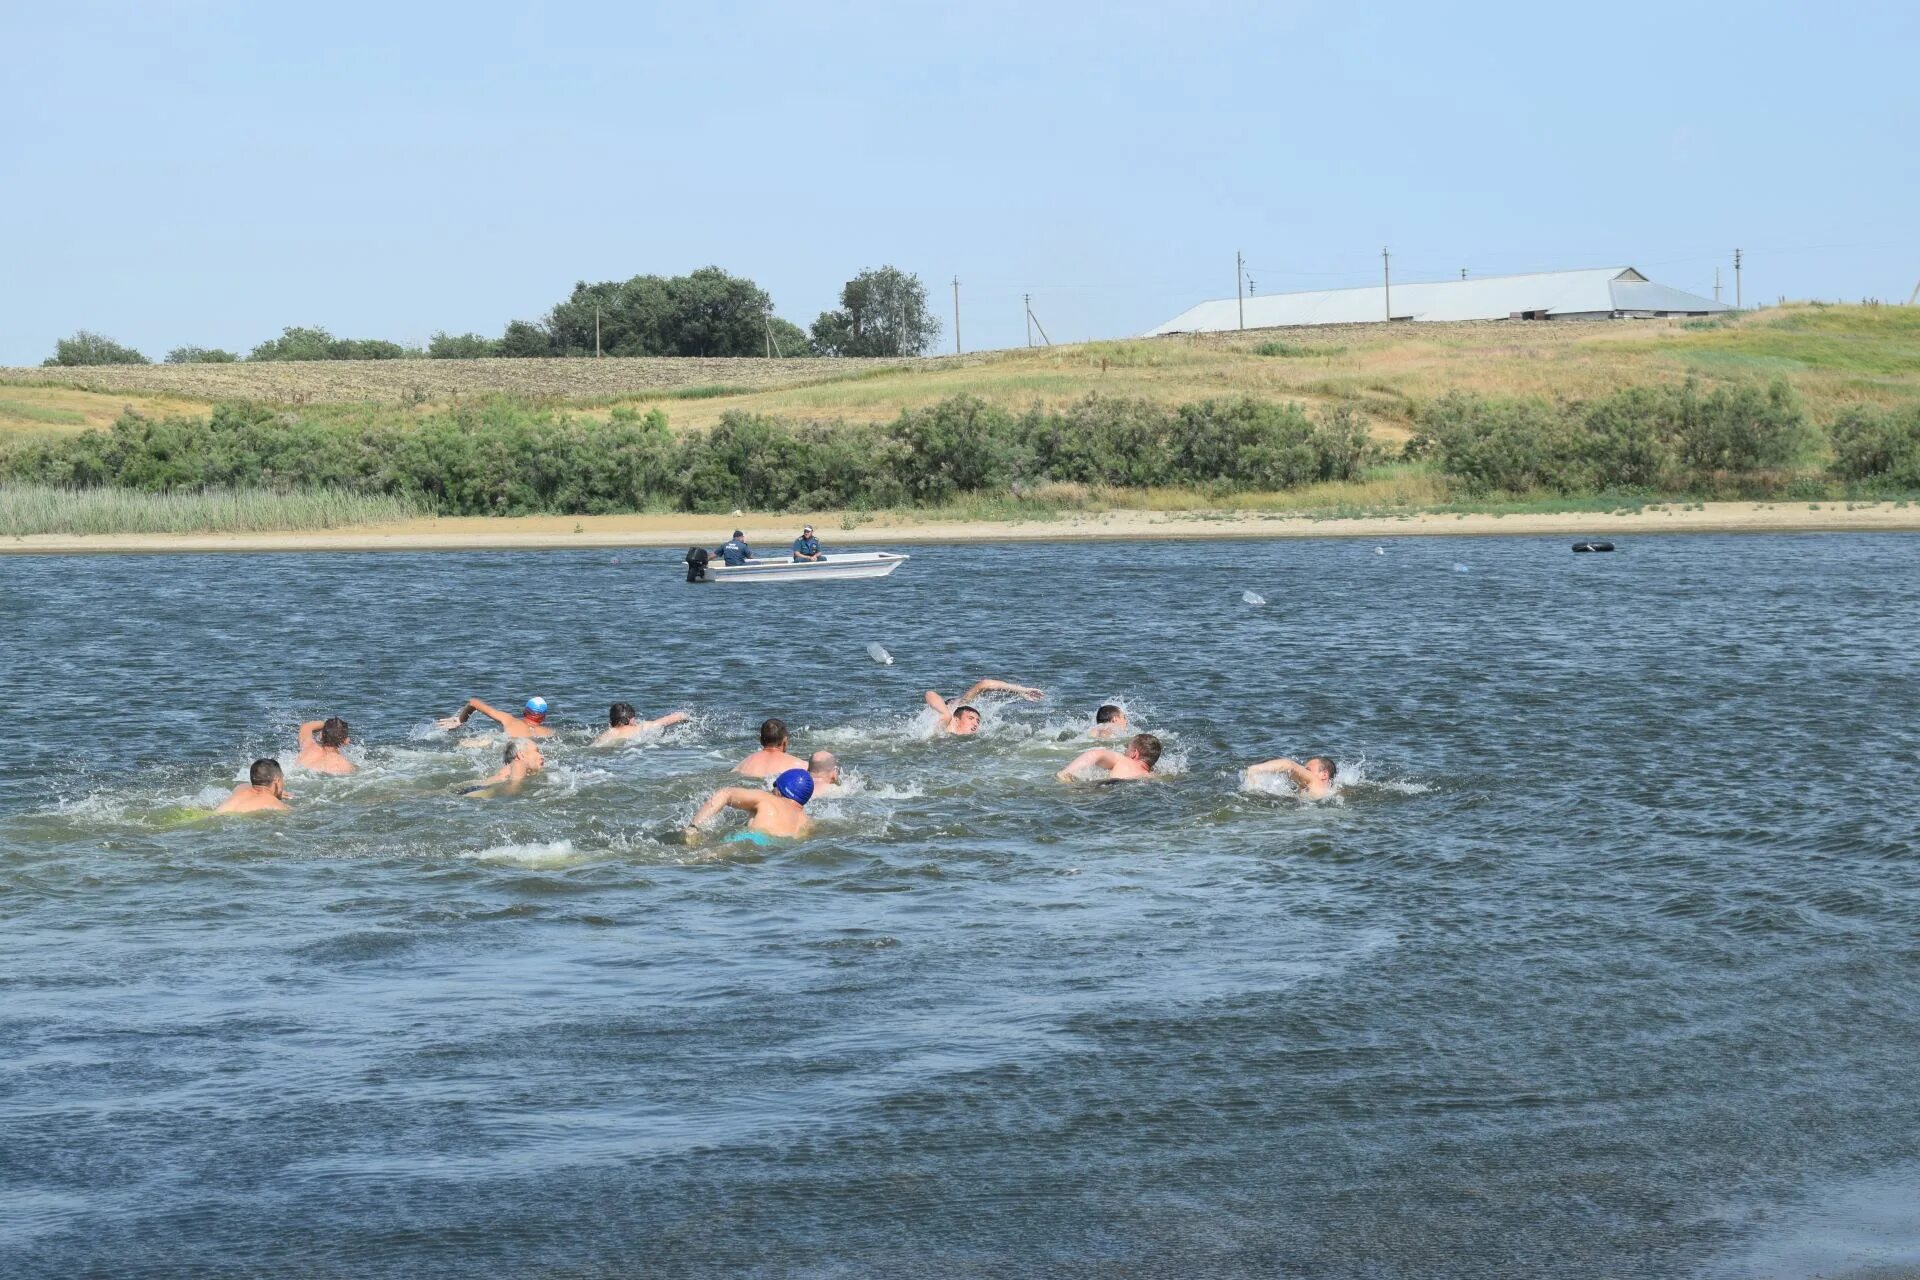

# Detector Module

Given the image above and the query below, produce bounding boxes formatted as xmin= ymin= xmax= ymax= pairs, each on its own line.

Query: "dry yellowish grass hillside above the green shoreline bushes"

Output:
xmin=0 ymin=305 xmax=1920 ymax=439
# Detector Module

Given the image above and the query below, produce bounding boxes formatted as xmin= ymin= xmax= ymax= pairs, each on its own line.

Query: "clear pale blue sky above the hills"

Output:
xmin=0 ymin=0 xmax=1920 ymax=365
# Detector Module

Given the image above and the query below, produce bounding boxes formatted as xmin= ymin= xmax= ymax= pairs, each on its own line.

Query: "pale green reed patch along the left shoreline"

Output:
xmin=0 ymin=484 xmax=426 ymax=537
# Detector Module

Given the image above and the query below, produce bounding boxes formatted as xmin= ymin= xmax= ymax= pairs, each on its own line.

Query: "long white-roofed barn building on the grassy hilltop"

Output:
xmin=1146 ymin=267 xmax=1732 ymax=338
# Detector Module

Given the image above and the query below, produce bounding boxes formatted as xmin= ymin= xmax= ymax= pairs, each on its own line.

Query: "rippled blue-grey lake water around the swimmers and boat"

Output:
xmin=0 ymin=535 xmax=1920 ymax=1278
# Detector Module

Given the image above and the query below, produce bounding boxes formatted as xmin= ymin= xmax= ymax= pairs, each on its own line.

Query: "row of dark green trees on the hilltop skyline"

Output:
xmin=46 ymin=267 xmax=941 ymax=365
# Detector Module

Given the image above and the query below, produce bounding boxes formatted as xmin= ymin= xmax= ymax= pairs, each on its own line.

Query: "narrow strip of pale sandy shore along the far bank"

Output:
xmin=0 ymin=503 xmax=1920 ymax=555
